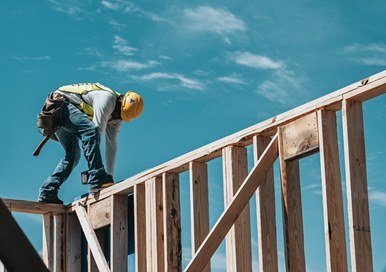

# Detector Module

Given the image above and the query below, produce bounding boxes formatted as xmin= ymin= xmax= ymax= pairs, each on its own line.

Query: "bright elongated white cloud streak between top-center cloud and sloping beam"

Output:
xmin=229 ymin=52 xmax=285 ymax=70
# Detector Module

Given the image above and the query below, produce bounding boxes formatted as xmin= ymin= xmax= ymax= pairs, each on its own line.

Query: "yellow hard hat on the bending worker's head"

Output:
xmin=121 ymin=91 xmax=143 ymax=122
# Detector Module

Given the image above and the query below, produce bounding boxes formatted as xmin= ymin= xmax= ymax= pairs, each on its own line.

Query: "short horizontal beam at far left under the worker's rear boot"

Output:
xmin=2 ymin=198 xmax=66 ymax=214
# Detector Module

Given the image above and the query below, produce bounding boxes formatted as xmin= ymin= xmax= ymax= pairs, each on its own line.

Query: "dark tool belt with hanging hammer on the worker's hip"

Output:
xmin=32 ymin=93 xmax=67 ymax=156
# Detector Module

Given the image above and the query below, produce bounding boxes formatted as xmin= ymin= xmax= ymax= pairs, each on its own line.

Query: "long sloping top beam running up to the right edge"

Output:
xmin=67 ymin=71 xmax=386 ymax=208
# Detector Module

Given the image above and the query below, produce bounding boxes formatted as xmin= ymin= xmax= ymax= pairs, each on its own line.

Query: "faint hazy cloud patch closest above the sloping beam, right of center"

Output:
xmin=256 ymin=69 xmax=305 ymax=106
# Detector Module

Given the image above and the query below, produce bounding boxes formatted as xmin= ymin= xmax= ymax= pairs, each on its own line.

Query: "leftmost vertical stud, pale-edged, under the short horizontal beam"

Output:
xmin=42 ymin=213 xmax=55 ymax=271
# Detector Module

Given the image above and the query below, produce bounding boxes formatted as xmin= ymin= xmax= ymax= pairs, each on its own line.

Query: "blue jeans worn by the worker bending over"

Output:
xmin=39 ymin=102 xmax=108 ymax=200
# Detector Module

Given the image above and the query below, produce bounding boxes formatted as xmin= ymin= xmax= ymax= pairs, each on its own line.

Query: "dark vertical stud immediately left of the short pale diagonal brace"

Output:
xmin=65 ymin=213 xmax=82 ymax=271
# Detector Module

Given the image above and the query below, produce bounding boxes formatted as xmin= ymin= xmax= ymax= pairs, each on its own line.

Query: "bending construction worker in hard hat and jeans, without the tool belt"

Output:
xmin=38 ymin=83 xmax=143 ymax=204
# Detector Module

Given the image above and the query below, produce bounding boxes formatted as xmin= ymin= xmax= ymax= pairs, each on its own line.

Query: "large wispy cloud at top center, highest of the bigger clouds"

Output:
xmin=183 ymin=6 xmax=247 ymax=43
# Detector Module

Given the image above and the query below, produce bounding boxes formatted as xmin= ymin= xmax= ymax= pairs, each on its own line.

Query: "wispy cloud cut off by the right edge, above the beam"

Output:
xmin=344 ymin=43 xmax=386 ymax=66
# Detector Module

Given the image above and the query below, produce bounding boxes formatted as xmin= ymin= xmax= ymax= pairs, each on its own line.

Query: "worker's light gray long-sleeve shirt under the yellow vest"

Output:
xmin=56 ymin=90 xmax=122 ymax=176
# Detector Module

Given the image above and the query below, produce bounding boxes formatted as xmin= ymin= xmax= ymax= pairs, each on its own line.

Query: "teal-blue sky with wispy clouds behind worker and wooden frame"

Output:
xmin=0 ymin=0 xmax=386 ymax=272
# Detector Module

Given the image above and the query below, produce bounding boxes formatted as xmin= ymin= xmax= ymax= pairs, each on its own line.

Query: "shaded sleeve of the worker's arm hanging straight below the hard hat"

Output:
xmin=105 ymin=120 xmax=122 ymax=176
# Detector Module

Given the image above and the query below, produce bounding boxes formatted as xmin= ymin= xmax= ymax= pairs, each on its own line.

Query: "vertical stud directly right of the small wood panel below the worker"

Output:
xmin=110 ymin=195 xmax=129 ymax=272
